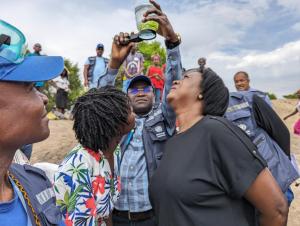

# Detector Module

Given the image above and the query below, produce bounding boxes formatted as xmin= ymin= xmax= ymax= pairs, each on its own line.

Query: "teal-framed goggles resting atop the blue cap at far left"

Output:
xmin=0 ymin=20 xmax=27 ymax=63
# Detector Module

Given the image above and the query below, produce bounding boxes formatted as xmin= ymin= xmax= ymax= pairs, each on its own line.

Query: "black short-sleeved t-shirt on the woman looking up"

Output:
xmin=150 ymin=116 xmax=266 ymax=226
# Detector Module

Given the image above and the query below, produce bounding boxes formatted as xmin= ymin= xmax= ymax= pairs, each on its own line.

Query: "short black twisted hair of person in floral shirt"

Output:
xmin=72 ymin=86 xmax=131 ymax=152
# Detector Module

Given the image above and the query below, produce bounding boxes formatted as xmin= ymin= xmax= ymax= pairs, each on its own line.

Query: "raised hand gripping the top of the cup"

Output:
xmin=143 ymin=0 xmax=178 ymax=42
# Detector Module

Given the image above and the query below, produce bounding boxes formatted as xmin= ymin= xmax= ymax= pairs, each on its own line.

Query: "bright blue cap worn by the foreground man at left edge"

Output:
xmin=0 ymin=56 xmax=64 ymax=82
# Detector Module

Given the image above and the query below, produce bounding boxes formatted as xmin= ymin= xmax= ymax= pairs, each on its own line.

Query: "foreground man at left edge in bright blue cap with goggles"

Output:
xmin=0 ymin=20 xmax=64 ymax=226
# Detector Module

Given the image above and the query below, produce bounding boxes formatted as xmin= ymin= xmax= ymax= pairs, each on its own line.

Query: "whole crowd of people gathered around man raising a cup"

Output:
xmin=0 ymin=0 xmax=300 ymax=226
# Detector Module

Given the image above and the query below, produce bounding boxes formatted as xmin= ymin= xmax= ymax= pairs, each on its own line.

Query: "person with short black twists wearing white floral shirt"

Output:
xmin=54 ymin=86 xmax=134 ymax=225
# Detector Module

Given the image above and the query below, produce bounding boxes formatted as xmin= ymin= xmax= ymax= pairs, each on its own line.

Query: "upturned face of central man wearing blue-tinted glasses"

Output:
xmin=128 ymin=81 xmax=154 ymax=115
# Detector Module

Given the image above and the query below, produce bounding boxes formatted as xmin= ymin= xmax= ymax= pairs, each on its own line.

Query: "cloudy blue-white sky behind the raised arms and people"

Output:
xmin=0 ymin=0 xmax=300 ymax=96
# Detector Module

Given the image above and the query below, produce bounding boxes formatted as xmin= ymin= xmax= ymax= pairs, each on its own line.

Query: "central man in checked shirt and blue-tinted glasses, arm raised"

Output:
xmin=104 ymin=1 xmax=182 ymax=226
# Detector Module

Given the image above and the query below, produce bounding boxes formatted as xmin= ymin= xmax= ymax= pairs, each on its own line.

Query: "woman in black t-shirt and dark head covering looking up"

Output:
xmin=150 ymin=68 xmax=288 ymax=226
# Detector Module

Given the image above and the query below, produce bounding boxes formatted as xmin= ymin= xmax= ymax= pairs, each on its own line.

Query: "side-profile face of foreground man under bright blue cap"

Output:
xmin=0 ymin=82 xmax=49 ymax=148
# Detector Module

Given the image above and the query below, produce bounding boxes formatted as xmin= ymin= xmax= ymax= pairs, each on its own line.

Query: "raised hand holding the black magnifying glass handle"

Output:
xmin=109 ymin=32 xmax=134 ymax=69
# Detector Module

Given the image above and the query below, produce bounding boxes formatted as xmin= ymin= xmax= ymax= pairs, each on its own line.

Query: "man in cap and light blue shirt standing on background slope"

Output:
xmin=83 ymin=43 xmax=109 ymax=89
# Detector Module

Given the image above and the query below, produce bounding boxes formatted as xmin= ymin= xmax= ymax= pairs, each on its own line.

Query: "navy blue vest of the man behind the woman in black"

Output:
xmin=225 ymin=90 xmax=299 ymax=192
